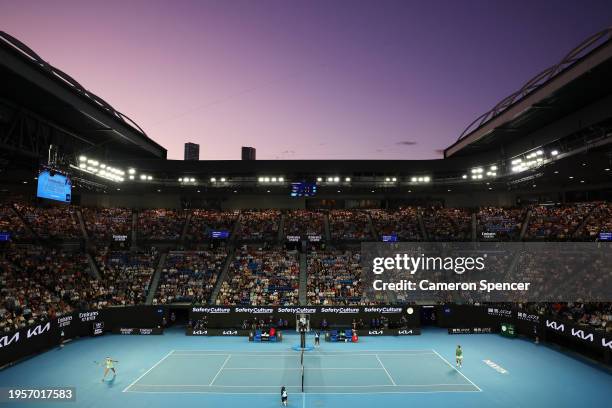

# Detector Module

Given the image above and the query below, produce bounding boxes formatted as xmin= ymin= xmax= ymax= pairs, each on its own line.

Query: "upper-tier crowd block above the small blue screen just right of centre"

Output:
xmin=369 ymin=207 xmax=423 ymax=241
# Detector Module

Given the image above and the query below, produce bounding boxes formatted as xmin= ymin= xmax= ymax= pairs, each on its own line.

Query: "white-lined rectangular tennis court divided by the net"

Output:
xmin=123 ymin=349 xmax=481 ymax=395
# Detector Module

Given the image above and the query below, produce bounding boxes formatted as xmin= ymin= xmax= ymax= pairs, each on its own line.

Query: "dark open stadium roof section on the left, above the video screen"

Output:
xmin=0 ymin=31 xmax=167 ymax=158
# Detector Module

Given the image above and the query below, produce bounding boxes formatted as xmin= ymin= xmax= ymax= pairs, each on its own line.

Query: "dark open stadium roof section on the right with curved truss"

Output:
xmin=444 ymin=27 xmax=612 ymax=157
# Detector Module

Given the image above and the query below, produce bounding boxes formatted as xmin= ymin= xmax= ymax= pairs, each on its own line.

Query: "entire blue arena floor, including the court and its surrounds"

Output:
xmin=0 ymin=329 xmax=612 ymax=408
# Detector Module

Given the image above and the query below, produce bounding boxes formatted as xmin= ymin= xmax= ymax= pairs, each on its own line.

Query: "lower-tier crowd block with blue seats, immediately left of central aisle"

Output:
xmin=216 ymin=248 xmax=300 ymax=306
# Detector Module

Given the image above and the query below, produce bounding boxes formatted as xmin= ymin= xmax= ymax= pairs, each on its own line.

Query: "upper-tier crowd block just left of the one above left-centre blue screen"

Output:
xmin=138 ymin=209 xmax=186 ymax=241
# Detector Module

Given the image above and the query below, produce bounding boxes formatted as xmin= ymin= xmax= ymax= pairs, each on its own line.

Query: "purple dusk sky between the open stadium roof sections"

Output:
xmin=0 ymin=0 xmax=612 ymax=159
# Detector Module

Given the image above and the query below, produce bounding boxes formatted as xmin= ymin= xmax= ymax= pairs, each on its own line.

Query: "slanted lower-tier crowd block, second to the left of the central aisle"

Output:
xmin=153 ymin=249 xmax=227 ymax=304
